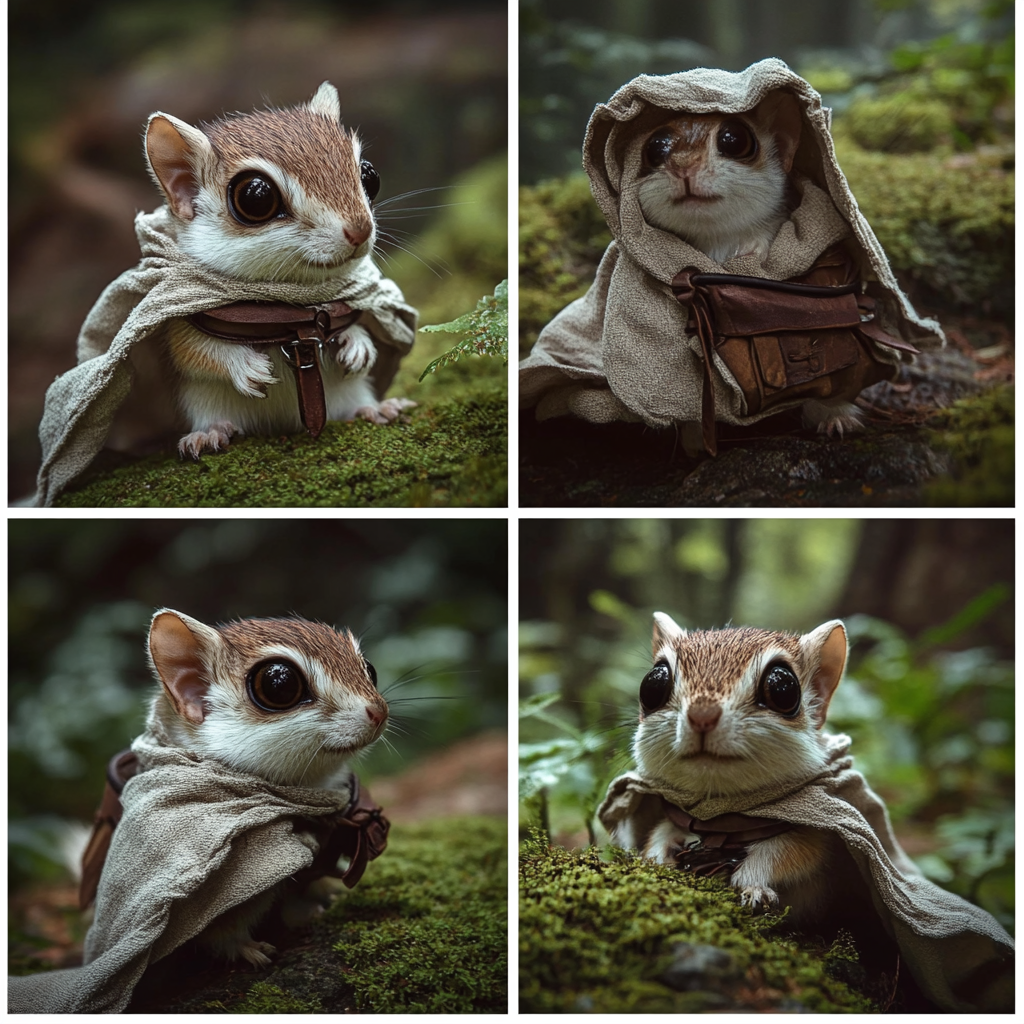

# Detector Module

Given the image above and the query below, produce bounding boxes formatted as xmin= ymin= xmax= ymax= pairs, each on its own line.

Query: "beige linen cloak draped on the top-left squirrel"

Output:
xmin=32 ymin=205 xmax=416 ymax=506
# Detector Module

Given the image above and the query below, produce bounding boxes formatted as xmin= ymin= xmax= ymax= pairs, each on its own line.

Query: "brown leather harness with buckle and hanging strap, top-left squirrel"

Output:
xmin=187 ymin=300 xmax=360 ymax=438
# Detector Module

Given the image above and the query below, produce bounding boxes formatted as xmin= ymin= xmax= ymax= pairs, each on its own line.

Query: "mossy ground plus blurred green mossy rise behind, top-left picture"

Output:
xmin=56 ymin=157 xmax=508 ymax=508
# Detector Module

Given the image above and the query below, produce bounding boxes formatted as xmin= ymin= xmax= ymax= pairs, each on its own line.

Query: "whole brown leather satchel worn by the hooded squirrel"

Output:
xmin=672 ymin=246 xmax=918 ymax=455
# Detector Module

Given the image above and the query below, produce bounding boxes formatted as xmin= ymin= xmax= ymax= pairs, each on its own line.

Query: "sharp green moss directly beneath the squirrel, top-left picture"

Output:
xmin=56 ymin=372 xmax=507 ymax=508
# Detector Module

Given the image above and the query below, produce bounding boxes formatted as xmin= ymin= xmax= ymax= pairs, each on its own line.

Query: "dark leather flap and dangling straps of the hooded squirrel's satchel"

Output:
xmin=671 ymin=247 xmax=918 ymax=455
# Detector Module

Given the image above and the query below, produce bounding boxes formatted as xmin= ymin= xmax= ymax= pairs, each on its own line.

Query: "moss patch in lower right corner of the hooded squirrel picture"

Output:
xmin=925 ymin=384 xmax=1015 ymax=508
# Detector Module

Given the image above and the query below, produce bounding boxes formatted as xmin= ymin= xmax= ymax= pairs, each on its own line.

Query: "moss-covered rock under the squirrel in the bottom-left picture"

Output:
xmin=128 ymin=817 xmax=508 ymax=1014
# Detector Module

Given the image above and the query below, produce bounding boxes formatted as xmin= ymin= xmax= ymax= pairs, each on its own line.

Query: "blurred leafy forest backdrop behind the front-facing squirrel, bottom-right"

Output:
xmin=519 ymin=519 xmax=1015 ymax=930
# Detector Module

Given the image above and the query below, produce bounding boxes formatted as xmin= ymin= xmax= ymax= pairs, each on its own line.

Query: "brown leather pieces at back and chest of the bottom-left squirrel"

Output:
xmin=78 ymin=751 xmax=391 ymax=910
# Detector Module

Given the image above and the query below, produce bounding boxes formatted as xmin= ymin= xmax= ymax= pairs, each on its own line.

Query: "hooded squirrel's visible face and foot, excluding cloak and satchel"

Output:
xmin=639 ymin=96 xmax=863 ymax=450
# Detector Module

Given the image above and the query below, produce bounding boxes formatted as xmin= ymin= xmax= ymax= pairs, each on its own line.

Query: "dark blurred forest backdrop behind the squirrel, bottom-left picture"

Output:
xmin=8 ymin=519 xmax=508 ymax=905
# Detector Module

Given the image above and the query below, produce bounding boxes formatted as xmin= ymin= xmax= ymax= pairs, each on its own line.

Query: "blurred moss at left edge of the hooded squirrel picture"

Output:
xmin=519 ymin=174 xmax=611 ymax=355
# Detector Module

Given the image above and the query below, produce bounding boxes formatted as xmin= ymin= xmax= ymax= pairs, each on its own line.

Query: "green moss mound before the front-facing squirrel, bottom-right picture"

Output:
xmin=519 ymin=842 xmax=874 ymax=1013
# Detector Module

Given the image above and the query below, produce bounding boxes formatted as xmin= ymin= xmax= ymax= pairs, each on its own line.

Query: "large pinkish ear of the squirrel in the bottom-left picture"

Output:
xmin=148 ymin=608 xmax=221 ymax=725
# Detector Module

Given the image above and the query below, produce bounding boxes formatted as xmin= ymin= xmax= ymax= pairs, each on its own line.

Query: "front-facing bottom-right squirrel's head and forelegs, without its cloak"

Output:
xmin=628 ymin=612 xmax=859 ymax=926
